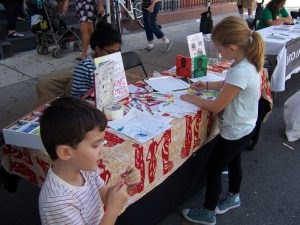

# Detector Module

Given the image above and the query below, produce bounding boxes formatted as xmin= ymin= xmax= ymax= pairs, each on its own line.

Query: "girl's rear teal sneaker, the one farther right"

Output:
xmin=216 ymin=193 xmax=241 ymax=214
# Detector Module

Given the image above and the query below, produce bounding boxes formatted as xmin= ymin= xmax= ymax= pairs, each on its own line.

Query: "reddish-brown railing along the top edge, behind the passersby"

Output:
xmin=162 ymin=0 xmax=236 ymax=12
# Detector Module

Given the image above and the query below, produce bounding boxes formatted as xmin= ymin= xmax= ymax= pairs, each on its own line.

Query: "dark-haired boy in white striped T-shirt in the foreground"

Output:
xmin=39 ymin=97 xmax=140 ymax=225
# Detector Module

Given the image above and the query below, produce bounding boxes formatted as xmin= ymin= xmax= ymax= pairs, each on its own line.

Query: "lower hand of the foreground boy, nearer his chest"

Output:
xmin=106 ymin=184 xmax=128 ymax=216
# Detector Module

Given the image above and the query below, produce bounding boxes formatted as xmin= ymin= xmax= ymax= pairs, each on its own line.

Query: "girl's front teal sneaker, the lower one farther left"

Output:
xmin=182 ymin=207 xmax=216 ymax=225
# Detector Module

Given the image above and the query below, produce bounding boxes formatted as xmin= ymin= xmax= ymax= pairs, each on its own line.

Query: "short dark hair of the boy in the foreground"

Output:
xmin=40 ymin=97 xmax=107 ymax=160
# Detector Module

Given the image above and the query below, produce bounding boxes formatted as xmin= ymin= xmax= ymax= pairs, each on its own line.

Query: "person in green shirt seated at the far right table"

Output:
xmin=257 ymin=0 xmax=294 ymax=30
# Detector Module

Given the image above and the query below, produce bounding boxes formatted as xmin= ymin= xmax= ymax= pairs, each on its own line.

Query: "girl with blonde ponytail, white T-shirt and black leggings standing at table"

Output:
xmin=181 ymin=16 xmax=265 ymax=224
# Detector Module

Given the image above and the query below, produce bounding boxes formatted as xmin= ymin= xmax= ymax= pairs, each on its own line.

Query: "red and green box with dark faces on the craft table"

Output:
xmin=176 ymin=55 xmax=208 ymax=78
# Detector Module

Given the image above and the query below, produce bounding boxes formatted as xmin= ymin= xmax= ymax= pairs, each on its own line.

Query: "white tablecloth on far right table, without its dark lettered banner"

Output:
xmin=258 ymin=24 xmax=300 ymax=92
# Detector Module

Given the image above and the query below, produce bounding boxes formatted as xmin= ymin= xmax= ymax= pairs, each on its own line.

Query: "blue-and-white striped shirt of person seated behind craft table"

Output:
xmin=71 ymin=55 xmax=96 ymax=98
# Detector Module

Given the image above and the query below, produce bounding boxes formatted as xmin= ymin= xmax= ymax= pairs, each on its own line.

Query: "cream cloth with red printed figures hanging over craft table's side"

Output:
xmin=1 ymin=110 xmax=218 ymax=208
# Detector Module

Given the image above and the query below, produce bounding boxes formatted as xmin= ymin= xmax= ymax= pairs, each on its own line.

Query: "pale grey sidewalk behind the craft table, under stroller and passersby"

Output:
xmin=0 ymin=13 xmax=236 ymax=128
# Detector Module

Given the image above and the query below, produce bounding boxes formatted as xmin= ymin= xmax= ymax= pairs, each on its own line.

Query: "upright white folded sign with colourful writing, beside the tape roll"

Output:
xmin=94 ymin=52 xmax=129 ymax=110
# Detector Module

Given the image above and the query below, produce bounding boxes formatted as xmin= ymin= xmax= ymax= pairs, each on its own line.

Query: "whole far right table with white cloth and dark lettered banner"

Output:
xmin=258 ymin=24 xmax=300 ymax=92
